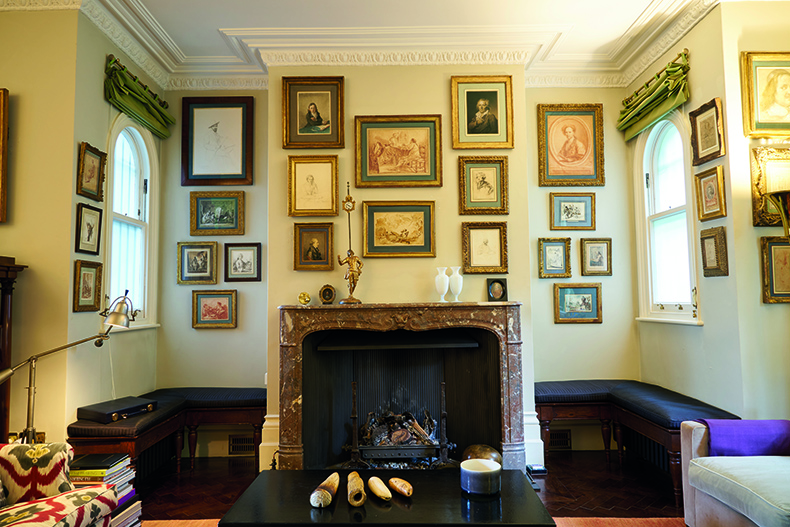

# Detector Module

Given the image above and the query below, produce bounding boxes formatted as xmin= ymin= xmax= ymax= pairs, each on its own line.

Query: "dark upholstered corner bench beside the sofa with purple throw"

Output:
xmin=535 ymin=379 xmax=740 ymax=507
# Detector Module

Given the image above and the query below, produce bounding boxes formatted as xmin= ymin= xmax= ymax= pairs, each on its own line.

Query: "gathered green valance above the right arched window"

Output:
xmin=617 ymin=50 xmax=689 ymax=141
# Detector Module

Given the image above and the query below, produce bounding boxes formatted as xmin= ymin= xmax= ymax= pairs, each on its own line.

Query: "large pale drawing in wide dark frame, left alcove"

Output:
xmin=181 ymin=97 xmax=255 ymax=186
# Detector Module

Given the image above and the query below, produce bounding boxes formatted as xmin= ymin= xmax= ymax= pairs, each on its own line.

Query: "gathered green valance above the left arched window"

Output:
xmin=104 ymin=55 xmax=176 ymax=139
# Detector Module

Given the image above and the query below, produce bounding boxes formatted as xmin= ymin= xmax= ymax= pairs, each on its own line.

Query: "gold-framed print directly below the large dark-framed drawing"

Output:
xmin=189 ymin=190 xmax=244 ymax=236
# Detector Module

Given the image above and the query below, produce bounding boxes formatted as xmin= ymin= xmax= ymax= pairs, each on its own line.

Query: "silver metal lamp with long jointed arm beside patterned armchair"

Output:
xmin=0 ymin=289 xmax=139 ymax=444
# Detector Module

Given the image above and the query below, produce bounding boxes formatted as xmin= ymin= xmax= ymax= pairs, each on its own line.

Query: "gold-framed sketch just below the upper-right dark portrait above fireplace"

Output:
xmin=458 ymin=156 xmax=508 ymax=214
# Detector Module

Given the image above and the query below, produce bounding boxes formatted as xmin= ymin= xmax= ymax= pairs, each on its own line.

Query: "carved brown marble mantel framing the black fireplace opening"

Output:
xmin=279 ymin=302 xmax=526 ymax=471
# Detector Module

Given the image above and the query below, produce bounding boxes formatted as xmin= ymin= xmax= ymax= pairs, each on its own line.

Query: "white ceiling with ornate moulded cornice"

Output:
xmin=82 ymin=0 xmax=719 ymax=89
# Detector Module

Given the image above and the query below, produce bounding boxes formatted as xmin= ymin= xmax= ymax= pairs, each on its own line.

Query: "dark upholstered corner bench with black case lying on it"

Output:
xmin=67 ymin=387 xmax=266 ymax=478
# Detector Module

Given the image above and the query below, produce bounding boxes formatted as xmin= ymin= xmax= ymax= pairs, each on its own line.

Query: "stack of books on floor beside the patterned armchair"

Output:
xmin=70 ymin=454 xmax=142 ymax=527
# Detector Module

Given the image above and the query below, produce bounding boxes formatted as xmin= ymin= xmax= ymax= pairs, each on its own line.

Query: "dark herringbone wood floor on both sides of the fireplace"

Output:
xmin=137 ymin=452 xmax=683 ymax=520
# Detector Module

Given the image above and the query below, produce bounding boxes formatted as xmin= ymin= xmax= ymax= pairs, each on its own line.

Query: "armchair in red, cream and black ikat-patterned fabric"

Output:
xmin=0 ymin=443 xmax=118 ymax=527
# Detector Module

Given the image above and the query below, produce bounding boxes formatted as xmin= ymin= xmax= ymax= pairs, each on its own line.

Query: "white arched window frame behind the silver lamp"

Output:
xmin=104 ymin=113 xmax=159 ymax=329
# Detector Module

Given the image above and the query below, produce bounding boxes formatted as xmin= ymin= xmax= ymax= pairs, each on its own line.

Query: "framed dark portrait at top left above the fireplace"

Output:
xmin=283 ymin=77 xmax=346 ymax=148
